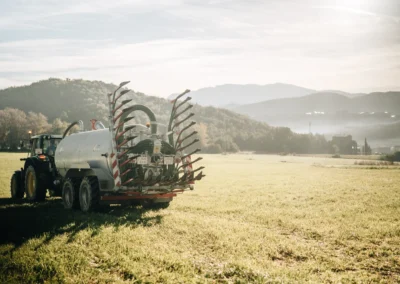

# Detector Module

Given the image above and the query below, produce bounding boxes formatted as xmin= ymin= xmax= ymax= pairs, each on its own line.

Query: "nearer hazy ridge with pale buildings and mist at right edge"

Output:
xmin=231 ymin=92 xmax=400 ymax=146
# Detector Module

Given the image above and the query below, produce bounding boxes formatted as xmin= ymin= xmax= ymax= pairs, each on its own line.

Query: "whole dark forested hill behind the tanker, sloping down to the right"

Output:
xmin=0 ymin=79 xmax=330 ymax=153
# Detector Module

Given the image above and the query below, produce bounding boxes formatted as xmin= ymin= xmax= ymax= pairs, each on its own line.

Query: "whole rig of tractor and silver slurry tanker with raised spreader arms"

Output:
xmin=11 ymin=82 xmax=204 ymax=212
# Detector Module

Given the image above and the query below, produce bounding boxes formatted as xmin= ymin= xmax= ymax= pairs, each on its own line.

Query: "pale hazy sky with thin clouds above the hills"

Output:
xmin=0 ymin=0 xmax=400 ymax=96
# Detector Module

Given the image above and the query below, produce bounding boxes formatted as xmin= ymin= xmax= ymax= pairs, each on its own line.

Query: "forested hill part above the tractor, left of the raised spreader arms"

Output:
xmin=0 ymin=79 xmax=117 ymax=122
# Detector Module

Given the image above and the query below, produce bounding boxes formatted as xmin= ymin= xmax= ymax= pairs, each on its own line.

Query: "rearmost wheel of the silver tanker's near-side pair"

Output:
xmin=79 ymin=177 xmax=100 ymax=212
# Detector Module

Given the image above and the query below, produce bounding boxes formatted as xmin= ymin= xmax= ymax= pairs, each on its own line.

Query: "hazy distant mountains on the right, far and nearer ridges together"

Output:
xmin=171 ymin=83 xmax=400 ymax=144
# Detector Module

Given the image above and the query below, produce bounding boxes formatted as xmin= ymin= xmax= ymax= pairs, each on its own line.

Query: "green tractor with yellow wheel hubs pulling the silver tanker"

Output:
xmin=11 ymin=134 xmax=62 ymax=201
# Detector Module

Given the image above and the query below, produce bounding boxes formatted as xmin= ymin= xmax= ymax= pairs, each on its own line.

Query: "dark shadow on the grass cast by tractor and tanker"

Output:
xmin=0 ymin=198 xmax=162 ymax=250
